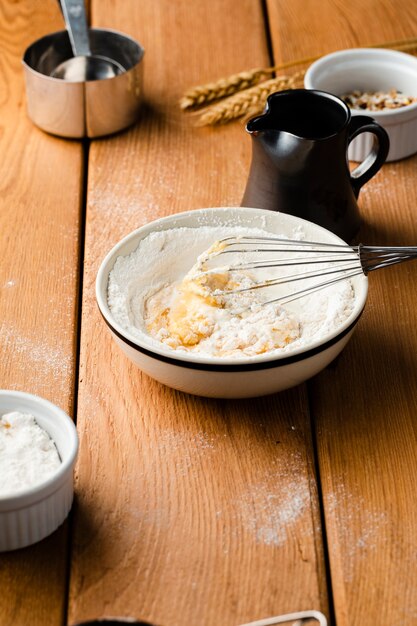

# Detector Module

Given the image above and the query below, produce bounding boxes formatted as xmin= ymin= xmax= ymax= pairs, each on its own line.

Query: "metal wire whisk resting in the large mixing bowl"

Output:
xmin=203 ymin=236 xmax=417 ymax=304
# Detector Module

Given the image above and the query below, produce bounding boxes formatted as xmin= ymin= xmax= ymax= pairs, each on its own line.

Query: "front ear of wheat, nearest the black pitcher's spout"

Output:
xmin=197 ymin=72 xmax=304 ymax=126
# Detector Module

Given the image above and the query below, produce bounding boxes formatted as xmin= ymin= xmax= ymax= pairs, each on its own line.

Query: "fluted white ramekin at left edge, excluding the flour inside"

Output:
xmin=0 ymin=389 xmax=78 ymax=552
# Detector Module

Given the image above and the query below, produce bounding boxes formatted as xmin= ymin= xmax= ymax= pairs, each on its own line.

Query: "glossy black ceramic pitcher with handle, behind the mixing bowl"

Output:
xmin=242 ymin=89 xmax=389 ymax=241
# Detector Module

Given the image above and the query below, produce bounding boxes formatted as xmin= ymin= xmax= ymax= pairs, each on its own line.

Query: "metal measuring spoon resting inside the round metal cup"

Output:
xmin=51 ymin=0 xmax=125 ymax=82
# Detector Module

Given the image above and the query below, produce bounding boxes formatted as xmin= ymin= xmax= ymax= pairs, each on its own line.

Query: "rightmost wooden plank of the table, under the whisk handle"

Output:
xmin=269 ymin=0 xmax=417 ymax=626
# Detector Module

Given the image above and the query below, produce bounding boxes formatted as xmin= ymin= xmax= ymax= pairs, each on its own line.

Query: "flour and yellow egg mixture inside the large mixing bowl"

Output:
xmin=108 ymin=226 xmax=354 ymax=358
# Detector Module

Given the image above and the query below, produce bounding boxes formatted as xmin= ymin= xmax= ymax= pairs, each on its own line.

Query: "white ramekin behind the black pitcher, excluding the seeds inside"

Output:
xmin=304 ymin=48 xmax=417 ymax=161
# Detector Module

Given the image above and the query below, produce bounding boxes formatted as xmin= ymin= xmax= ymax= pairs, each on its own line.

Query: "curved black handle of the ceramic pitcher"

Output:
xmin=348 ymin=115 xmax=389 ymax=197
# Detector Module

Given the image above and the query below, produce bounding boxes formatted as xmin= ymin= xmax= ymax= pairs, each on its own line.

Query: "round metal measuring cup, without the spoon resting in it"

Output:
xmin=22 ymin=28 xmax=144 ymax=138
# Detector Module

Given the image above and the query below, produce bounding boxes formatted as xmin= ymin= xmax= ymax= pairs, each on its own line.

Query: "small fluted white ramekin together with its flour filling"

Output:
xmin=0 ymin=389 xmax=78 ymax=552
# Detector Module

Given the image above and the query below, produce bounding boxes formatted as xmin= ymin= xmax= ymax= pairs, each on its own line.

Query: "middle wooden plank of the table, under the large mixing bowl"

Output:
xmin=69 ymin=0 xmax=327 ymax=626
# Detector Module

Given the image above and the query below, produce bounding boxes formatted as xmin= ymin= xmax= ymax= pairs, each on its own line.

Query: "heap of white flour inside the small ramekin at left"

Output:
xmin=0 ymin=411 xmax=61 ymax=496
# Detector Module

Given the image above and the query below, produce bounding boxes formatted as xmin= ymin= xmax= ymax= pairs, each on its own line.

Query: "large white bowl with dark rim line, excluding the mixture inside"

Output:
xmin=96 ymin=207 xmax=368 ymax=398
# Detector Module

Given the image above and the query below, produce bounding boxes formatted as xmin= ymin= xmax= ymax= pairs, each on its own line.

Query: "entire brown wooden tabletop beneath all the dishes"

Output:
xmin=0 ymin=0 xmax=417 ymax=626
